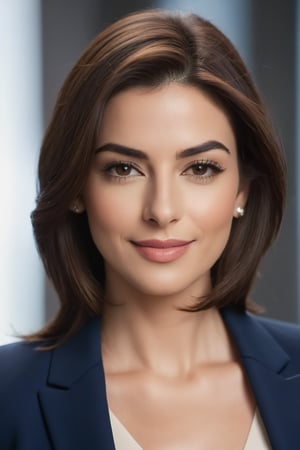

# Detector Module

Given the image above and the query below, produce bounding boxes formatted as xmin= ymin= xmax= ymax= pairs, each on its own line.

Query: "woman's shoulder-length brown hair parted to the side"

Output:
xmin=29 ymin=10 xmax=285 ymax=345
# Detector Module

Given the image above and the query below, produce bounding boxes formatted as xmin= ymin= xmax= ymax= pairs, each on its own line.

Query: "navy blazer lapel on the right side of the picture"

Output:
xmin=221 ymin=308 xmax=300 ymax=450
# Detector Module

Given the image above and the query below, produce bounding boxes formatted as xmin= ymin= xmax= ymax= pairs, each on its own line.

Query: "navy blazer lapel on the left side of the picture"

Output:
xmin=39 ymin=319 xmax=115 ymax=450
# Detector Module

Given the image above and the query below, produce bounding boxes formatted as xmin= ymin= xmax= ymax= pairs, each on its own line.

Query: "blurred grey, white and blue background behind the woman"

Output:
xmin=0 ymin=0 xmax=300 ymax=344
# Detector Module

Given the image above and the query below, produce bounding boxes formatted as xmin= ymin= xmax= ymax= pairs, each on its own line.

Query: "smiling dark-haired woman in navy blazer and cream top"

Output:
xmin=0 ymin=7 xmax=300 ymax=450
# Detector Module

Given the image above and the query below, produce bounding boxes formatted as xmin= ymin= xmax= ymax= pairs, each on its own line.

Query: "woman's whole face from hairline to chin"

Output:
xmin=82 ymin=83 xmax=246 ymax=302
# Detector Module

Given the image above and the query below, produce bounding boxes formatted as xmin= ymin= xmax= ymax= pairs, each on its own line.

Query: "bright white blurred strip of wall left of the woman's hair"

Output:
xmin=0 ymin=0 xmax=44 ymax=343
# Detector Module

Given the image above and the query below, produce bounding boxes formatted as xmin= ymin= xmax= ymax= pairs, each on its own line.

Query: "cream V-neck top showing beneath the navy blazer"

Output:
xmin=109 ymin=410 xmax=272 ymax=450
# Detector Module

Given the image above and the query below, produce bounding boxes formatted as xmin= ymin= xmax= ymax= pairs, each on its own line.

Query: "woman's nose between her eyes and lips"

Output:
xmin=143 ymin=177 xmax=181 ymax=228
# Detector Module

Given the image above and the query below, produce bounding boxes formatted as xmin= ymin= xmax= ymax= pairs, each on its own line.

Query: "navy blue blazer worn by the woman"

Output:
xmin=0 ymin=308 xmax=300 ymax=450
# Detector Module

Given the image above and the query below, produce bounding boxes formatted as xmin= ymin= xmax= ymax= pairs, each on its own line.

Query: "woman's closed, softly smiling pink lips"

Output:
xmin=131 ymin=239 xmax=193 ymax=263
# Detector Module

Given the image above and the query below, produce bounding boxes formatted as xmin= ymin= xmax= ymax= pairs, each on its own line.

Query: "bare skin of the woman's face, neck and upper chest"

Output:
xmin=78 ymin=83 xmax=254 ymax=450
